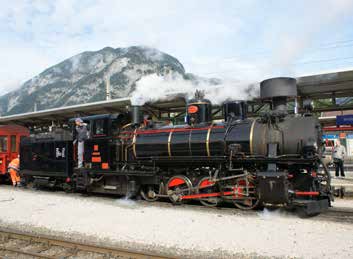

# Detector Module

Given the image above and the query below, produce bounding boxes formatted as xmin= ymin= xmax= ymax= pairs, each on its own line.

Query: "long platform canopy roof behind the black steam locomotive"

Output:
xmin=0 ymin=70 xmax=353 ymax=126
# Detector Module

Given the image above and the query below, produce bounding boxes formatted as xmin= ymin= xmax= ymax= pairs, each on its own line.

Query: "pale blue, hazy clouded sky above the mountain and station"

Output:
xmin=0 ymin=0 xmax=353 ymax=95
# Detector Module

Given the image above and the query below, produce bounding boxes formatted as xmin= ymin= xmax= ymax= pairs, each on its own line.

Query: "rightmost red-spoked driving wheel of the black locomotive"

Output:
xmin=233 ymin=178 xmax=260 ymax=210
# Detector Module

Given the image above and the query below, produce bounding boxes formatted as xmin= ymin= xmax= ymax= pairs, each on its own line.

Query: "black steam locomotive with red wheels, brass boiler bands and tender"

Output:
xmin=21 ymin=78 xmax=332 ymax=215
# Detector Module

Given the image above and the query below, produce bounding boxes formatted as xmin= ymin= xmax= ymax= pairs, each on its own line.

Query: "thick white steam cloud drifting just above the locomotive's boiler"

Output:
xmin=131 ymin=73 xmax=258 ymax=105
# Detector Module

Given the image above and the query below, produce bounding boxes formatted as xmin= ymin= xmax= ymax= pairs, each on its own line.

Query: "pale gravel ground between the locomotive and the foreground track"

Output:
xmin=0 ymin=186 xmax=353 ymax=258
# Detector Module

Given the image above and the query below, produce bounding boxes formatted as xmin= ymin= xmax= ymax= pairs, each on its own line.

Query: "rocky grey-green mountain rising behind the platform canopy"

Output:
xmin=0 ymin=46 xmax=186 ymax=116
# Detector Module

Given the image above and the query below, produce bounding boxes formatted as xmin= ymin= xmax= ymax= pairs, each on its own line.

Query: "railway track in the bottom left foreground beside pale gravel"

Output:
xmin=0 ymin=229 xmax=174 ymax=259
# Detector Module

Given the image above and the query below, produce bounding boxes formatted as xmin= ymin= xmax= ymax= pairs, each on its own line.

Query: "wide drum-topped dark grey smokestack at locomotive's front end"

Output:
xmin=260 ymin=77 xmax=297 ymax=112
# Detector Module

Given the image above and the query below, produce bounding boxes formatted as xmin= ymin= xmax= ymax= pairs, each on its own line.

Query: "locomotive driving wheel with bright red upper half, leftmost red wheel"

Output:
xmin=166 ymin=175 xmax=192 ymax=204
